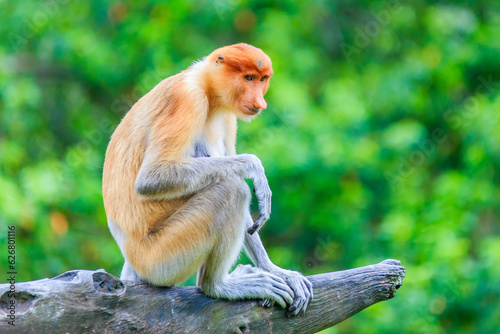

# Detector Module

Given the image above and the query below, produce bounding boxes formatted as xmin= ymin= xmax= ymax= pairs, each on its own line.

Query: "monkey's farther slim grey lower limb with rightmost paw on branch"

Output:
xmin=245 ymin=233 xmax=313 ymax=316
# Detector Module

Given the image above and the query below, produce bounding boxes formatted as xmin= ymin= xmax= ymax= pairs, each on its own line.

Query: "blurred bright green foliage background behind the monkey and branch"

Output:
xmin=0 ymin=0 xmax=500 ymax=333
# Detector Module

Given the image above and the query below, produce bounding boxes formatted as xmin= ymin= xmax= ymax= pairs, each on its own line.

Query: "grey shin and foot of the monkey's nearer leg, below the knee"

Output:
xmin=198 ymin=177 xmax=294 ymax=308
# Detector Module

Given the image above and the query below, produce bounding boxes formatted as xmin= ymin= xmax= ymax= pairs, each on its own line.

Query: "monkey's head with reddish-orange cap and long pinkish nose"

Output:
xmin=206 ymin=43 xmax=273 ymax=121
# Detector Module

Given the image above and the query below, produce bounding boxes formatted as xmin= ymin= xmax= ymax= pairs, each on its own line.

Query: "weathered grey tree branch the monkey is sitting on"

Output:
xmin=0 ymin=260 xmax=405 ymax=334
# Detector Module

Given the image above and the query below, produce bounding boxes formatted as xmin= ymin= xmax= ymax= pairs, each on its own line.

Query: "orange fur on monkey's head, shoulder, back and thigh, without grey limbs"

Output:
xmin=103 ymin=43 xmax=272 ymax=283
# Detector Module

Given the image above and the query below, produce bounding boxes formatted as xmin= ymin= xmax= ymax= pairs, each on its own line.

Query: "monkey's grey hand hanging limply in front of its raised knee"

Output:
xmin=245 ymin=154 xmax=272 ymax=234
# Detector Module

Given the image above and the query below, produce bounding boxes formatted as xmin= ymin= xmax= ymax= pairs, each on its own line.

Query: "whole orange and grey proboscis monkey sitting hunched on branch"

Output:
xmin=103 ymin=43 xmax=312 ymax=315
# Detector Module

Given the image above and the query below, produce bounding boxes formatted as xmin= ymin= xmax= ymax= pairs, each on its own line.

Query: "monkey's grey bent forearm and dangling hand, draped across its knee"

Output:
xmin=135 ymin=152 xmax=272 ymax=233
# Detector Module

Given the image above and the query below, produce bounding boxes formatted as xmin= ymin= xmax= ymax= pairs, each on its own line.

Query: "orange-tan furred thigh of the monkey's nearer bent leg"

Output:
xmin=124 ymin=184 xmax=221 ymax=286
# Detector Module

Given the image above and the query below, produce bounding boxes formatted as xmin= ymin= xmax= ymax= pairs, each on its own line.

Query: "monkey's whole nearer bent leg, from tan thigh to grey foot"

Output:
xmin=125 ymin=176 xmax=293 ymax=307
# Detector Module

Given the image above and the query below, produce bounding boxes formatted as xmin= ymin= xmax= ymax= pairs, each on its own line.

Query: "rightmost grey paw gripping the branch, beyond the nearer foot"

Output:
xmin=260 ymin=265 xmax=313 ymax=317
